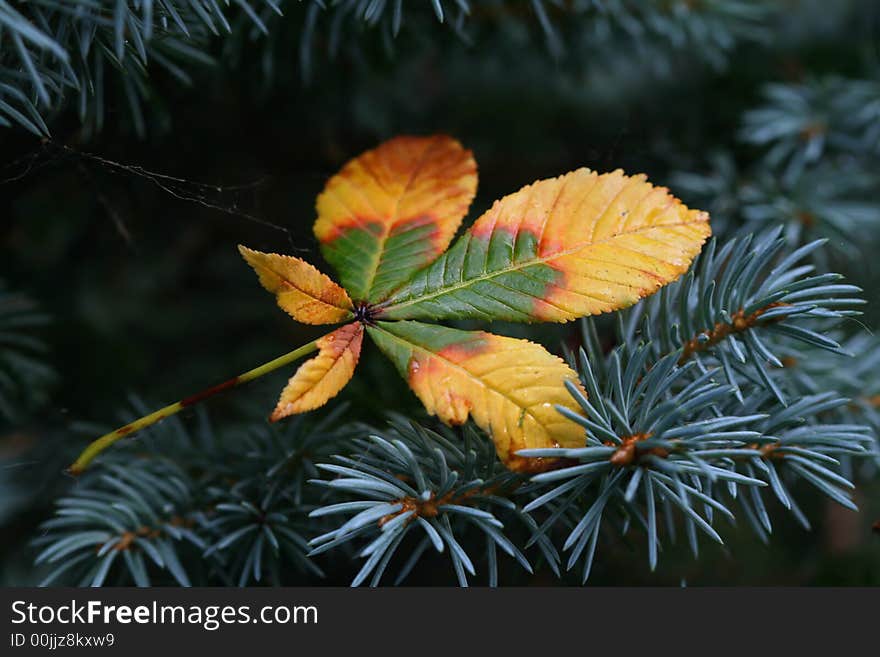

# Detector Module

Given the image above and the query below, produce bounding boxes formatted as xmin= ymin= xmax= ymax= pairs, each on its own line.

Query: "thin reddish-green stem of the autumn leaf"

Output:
xmin=67 ymin=340 xmax=318 ymax=475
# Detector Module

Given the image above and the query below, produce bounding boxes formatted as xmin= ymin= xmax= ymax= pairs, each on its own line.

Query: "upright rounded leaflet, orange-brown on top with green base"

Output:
xmin=315 ymin=135 xmax=477 ymax=301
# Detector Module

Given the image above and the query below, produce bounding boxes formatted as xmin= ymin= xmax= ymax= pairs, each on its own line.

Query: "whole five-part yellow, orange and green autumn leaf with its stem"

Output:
xmin=71 ymin=136 xmax=710 ymax=472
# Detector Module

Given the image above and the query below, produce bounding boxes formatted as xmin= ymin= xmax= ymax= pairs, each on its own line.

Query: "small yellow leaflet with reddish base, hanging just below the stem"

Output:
xmin=269 ymin=322 xmax=364 ymax=422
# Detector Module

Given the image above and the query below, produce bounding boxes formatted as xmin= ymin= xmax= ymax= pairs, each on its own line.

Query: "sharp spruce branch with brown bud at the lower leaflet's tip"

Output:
xmin=521 ymin=336 xmax=873 ymax=581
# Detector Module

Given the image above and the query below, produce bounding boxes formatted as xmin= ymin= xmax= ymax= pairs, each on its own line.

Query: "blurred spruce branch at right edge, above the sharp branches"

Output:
xmin=674 ymin=76 xmax=880 ymax=255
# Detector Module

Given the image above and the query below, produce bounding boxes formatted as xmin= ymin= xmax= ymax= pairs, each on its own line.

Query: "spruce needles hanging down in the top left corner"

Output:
xmin=0 ymin=0 xmax=280 ymax=137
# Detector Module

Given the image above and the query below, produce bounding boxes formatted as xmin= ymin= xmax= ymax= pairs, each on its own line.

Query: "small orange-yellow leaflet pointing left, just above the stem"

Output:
xmin=238 ymin=246 xmax=354 ymax=324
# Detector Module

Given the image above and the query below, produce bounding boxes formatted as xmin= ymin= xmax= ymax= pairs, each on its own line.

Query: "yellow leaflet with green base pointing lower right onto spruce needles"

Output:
xmin=367 ymin=321 xmax=586 ymax=470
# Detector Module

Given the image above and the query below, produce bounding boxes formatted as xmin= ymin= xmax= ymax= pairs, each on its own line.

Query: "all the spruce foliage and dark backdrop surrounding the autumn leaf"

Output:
xmin=0 ymin=0 xmax=880 ymax=586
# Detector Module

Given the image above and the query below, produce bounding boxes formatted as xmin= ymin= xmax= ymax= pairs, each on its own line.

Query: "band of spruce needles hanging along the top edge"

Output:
xmin=0 ymin=0 xmax=770 ymax=136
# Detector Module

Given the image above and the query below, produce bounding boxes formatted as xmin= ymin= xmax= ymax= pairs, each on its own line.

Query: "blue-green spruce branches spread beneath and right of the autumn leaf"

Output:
xmin=27 ymin=233 xmax=876 ymax=586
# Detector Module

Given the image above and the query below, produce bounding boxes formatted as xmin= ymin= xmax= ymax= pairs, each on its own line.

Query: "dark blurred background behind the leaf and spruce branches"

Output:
xmin=0 ymin=0 xmax=880 ymax=585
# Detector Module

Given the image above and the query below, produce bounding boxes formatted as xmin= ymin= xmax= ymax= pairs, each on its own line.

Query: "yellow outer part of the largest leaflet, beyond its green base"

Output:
xmin=520 ymin=169 xmax=711 ymax=321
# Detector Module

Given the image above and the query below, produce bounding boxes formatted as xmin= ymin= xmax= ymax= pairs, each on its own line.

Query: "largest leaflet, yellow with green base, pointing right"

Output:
xmin=376 ymin=169 xmax=710 ymax=322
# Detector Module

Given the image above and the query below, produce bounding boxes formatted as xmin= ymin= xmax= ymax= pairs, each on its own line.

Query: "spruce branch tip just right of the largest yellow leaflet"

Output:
xmin=627 ymin=229 xmax=864 ymax=404
